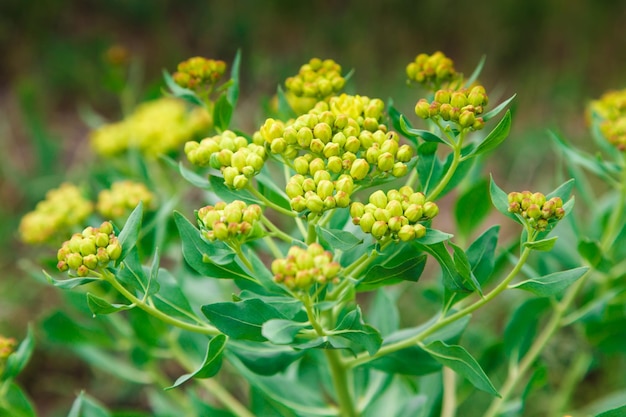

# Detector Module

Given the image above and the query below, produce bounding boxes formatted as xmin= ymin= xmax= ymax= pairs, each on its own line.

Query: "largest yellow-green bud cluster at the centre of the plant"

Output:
xmin=257 ymin=94 xmax=414 ymax=213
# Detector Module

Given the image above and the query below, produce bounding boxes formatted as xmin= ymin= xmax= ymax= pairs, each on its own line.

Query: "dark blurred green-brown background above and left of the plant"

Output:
xmin=0 ymin=0 xmax=626 ymax=415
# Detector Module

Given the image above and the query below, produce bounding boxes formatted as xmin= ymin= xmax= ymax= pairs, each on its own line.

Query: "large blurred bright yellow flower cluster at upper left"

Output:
xmin=91 ymin=98 xmax=213 ymax=157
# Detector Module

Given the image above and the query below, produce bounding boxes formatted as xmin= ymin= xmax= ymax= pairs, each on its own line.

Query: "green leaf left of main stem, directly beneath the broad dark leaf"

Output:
xmin=228 ymin=340 xmax=305 ymax=375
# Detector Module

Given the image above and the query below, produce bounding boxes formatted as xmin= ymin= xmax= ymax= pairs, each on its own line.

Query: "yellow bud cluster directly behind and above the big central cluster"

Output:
xmin=285 ymin=58 xmax=346 ymax=100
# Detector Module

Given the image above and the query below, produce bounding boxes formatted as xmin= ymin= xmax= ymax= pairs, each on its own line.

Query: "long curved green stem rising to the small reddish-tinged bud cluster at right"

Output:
xmin=346 ymin=248 xmax=532 ymax=367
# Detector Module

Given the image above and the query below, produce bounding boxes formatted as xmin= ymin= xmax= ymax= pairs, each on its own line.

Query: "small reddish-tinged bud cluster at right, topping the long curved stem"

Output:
xmin=508 ymin=191 xmax=565 ymax=231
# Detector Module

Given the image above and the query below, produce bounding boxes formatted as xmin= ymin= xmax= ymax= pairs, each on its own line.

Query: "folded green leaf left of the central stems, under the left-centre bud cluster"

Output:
xmin=174 ymin=212 xmax=254 ymax=281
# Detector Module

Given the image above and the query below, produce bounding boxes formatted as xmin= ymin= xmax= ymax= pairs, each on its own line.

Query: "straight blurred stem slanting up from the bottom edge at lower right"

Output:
xmin=484 ymin=271 xmax=589 ymax=417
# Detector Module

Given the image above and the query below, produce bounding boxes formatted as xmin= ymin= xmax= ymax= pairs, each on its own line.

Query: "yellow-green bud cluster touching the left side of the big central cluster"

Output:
xmin=185 ymin=130 xmax=267 ymax=190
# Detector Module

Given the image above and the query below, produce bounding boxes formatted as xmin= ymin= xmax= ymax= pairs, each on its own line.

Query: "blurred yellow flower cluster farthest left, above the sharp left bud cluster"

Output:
xmin=19 ymin=183 xmax=93 ymax=244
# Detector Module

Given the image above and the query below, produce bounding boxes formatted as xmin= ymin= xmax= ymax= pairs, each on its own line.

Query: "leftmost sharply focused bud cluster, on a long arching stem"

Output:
xmin=57 ymin=222 xmax=122 ymax=277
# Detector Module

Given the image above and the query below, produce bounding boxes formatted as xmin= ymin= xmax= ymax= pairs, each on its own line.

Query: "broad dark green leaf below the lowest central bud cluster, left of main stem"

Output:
xmin=202 ymin=298 xmax=287 ymax=342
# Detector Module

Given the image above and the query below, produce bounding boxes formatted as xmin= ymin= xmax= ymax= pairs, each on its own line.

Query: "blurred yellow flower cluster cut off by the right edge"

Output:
xmin=589 ymin=90 xmax=626 ymax=151
